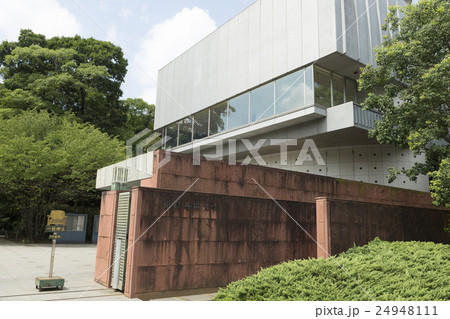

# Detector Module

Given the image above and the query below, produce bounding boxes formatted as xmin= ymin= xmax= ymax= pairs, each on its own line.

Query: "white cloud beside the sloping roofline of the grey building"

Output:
xmin=136 ymin=7 xmax=217 ymax=103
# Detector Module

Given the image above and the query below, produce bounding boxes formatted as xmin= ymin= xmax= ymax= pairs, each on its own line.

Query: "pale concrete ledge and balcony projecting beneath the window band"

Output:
xmin=171 ymin=102 xmax=381 ymax=158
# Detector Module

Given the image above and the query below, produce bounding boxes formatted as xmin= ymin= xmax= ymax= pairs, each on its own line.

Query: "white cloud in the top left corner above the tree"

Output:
xmin=0 ymin=0 xmax=81 ymax=41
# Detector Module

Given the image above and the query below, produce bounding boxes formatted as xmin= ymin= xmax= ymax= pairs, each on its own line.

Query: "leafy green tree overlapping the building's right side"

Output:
xmin=359 ymin=0 xmax=450 ymax=207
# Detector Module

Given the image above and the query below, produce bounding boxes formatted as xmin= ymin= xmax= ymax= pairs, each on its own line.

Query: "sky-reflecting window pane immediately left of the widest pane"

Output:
xmin=250 ymin=82 xmax=275 ymax=122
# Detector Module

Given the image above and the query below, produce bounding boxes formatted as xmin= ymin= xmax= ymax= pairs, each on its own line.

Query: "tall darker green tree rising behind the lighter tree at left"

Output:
xmin=0 ymin=30 xmax=127 ymax=139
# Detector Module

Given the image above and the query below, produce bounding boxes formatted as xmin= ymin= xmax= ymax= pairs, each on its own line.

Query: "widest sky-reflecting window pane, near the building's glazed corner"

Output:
xmin=275 ymin=70 xmax=305 ymax=114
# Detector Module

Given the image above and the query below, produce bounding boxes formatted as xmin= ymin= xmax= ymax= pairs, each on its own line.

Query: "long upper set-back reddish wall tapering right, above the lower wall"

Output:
xmin=141 ymin=151 xmax=438 ymax=208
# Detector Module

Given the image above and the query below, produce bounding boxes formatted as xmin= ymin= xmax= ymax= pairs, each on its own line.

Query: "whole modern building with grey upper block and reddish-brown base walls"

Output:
xmin=95 ymin=0 xmax=448 ymax=299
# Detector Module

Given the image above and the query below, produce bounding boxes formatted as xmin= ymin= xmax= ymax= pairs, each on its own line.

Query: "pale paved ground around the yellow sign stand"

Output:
xmin=0 ymin=239 xmax=214 ymax=301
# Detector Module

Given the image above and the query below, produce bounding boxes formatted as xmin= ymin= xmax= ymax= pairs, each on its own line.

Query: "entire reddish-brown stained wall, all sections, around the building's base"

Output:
xmin=95 ymin=151 xmax=448 ymax=298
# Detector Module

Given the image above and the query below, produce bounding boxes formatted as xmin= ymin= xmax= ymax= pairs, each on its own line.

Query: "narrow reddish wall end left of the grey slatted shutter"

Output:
xmin=94 ymin=191 xmax=119 ymax=287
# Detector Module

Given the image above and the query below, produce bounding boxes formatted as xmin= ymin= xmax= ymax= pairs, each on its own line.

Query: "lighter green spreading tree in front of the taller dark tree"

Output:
xmin=0 ymin=111 xmax=125 ymax=240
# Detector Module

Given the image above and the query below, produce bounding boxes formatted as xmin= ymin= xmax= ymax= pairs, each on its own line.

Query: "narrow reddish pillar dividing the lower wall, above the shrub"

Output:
xmin=316 ymin=197 xmax=331 ymax=259
